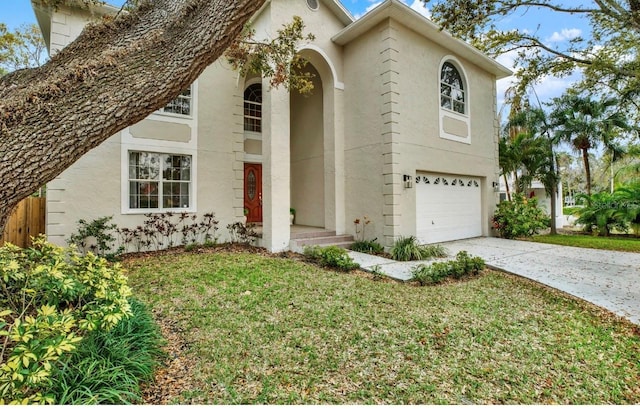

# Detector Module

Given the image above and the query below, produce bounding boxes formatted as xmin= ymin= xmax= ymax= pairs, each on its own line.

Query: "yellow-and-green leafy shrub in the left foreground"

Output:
xmin=0 ymin=237 xmax=131 ymax=405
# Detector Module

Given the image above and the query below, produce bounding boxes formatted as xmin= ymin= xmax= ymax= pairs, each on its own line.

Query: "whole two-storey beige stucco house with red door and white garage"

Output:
xmin=34 ymin=0 xmax=511 ymax=252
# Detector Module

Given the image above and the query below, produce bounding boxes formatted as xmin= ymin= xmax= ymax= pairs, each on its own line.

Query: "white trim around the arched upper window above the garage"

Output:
xmin=437 ymin=55 xmax=472 ymax=145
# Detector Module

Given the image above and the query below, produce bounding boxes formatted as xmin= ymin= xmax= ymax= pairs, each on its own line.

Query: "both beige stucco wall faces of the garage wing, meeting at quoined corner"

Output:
xmin=345 ymin=20 xmax=497 ymax=246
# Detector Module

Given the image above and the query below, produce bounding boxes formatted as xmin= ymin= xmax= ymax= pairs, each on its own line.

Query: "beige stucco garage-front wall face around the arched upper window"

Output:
xmin=394 ymin=24 xmax=498 ymax=236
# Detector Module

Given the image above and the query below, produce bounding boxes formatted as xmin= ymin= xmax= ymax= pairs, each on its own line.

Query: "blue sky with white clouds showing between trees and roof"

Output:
xmin=0 ymin=0 xmax=590 ymax=105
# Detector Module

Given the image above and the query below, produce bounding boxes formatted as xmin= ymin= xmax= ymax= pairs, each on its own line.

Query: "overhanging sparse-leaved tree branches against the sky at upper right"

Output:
xmin=427 ymin=0 xmax=640 ymax=107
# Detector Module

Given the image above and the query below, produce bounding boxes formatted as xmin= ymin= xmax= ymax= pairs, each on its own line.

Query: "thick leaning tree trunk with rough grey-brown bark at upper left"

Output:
xmin=0 ymin=0 xmax=265 ymax=232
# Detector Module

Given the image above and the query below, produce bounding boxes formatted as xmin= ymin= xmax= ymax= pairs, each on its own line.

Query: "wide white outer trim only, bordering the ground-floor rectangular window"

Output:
xmin=120 ymin=144 xmax=198 ymax=215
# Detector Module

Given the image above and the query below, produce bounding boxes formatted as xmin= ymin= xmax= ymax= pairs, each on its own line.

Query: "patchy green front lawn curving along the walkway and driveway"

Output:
xmin=125 ymin=250 xmax=640 ymax=404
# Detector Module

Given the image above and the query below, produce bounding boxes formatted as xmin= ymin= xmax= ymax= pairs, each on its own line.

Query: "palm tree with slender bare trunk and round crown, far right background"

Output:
xmin=551 ymin=92 xmax=630 ymax=195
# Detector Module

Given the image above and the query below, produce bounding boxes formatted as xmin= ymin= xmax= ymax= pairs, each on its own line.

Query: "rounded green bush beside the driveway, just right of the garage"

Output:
xmin=492 ymin=195 xmax=549 ymax=239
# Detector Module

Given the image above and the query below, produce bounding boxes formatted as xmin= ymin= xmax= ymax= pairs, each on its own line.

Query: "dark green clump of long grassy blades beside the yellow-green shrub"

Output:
xmin=51 ymin=299 xmax=164 ymax=405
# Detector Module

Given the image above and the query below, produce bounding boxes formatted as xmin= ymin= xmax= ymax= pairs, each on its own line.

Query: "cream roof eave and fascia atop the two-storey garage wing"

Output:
xmin=332 ymin=0 xmax=513 ymax=79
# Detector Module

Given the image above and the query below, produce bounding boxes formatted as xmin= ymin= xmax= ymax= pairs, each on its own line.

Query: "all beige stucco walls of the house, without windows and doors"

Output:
xmin=48 ymin=1 xmax=497 ymax=250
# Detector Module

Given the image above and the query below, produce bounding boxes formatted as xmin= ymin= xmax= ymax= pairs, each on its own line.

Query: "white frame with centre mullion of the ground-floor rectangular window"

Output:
xmin=121 ymin=145 xmax=198 ymax=214
